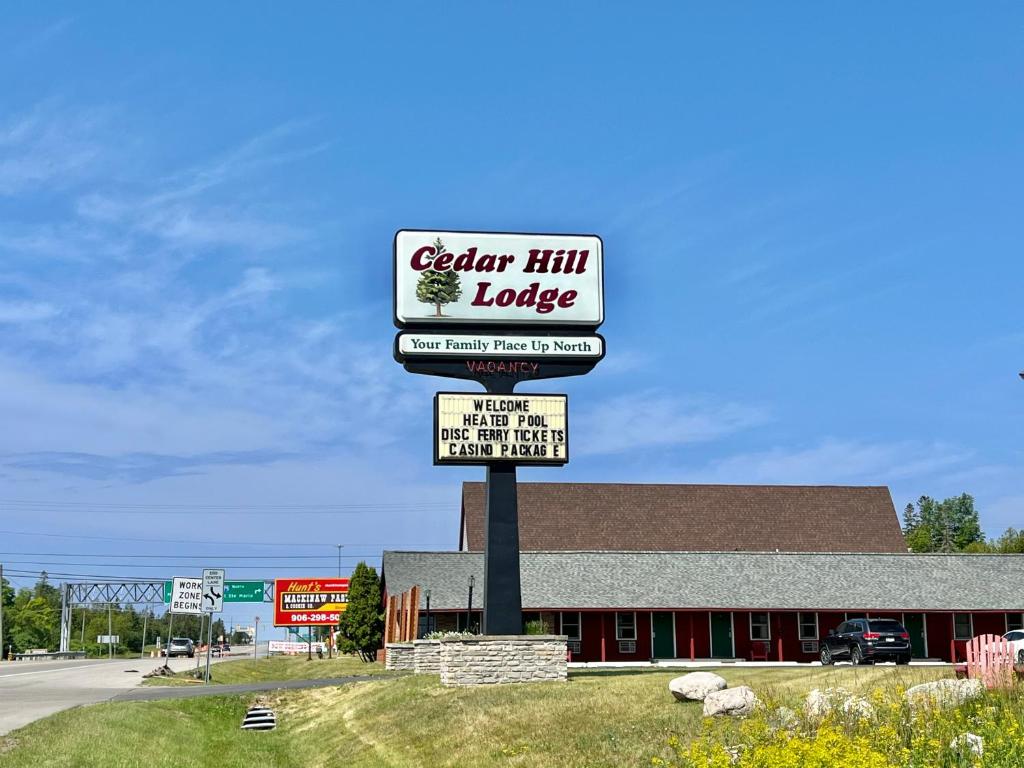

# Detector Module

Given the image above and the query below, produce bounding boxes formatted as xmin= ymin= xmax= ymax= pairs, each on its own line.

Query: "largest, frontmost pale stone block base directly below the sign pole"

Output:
xmin=438 ymin=635 xmax=568 ymax=686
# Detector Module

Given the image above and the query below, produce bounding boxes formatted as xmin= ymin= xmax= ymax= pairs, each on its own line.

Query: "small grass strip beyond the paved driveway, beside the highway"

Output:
xmin=144 ymin=656 xmax=390 ymax=685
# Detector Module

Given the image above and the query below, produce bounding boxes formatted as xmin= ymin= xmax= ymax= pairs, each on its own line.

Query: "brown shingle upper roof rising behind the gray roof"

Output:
xmin=459 ymin=482 xmax=906 ymax=552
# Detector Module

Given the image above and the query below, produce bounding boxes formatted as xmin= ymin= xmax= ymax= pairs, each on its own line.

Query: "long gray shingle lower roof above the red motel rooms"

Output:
xmin=383 ymin=552 xmax=1024 ymax=611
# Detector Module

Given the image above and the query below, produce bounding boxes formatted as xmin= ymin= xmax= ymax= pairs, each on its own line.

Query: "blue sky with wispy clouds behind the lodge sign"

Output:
xmin=0 ymin=3 xmax=1024 ymax=614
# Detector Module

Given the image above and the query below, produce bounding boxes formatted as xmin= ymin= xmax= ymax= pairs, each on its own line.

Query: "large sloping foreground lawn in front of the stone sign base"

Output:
xmin=0 ymin=657 xmax=950 ymax=768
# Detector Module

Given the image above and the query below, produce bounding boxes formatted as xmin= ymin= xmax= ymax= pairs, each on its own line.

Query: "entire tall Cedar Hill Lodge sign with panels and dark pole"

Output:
xmin=394 ymin=229 xmax=604 ymax=635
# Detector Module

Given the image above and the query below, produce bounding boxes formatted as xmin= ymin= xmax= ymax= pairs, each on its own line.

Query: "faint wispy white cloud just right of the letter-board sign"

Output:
xmin=570 ymin=390 xmax=768 ymax=455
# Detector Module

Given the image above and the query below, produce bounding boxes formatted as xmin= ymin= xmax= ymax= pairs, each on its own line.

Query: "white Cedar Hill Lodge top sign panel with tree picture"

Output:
xmin=394 ymin=229 xmax=604 ymax=330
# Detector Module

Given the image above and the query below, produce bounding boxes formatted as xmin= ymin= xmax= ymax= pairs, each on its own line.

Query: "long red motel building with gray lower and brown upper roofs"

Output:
xmin=382 ymin=482 xmax=1024 ymax=663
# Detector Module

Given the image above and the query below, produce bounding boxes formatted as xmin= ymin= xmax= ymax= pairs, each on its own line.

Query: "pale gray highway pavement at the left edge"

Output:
xmin=0 ymin=643 xmax=266 ymax=736
